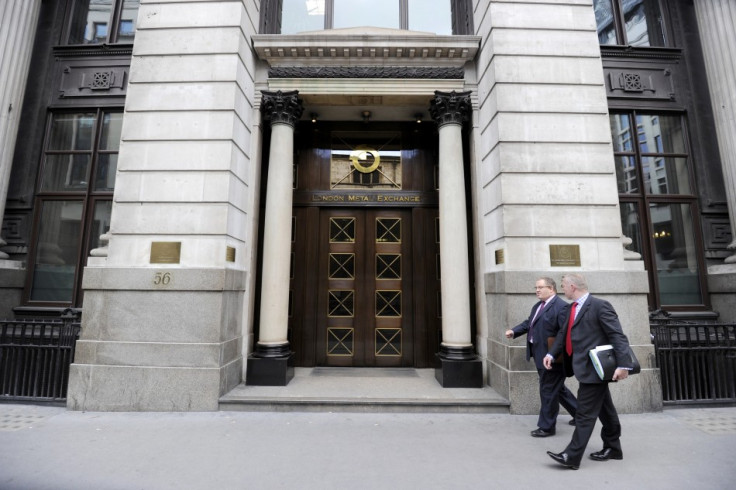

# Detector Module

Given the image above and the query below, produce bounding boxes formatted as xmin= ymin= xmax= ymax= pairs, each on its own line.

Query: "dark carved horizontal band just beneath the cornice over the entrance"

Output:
xmin=268 ymin=66 xmax=465 ymax=80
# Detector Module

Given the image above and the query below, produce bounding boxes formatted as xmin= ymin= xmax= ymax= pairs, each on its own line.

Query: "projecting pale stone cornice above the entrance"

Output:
xmin=252 ymin=28 xmax=481 ymax=67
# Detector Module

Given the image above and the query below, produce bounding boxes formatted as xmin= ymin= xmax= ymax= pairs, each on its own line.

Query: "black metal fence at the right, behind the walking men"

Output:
xmin=650 ymin=321 xmax=736 ymax=404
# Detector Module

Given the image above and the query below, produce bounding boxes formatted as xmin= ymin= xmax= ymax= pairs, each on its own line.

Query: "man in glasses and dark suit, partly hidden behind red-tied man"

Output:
xmin=506 ymin=277 xmax=578 ymax=437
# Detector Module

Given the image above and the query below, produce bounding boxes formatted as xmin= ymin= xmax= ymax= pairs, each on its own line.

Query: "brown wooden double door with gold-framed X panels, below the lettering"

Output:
xmin=290 ymin=207 xmax=440 ymax=367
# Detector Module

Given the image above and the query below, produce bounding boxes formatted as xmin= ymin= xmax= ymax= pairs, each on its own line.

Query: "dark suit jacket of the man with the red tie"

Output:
xmin=549 ymin=295 xmax=634 ymax=383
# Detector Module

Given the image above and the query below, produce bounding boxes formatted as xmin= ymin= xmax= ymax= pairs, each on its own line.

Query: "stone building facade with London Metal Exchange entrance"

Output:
xmin=0 ymin=0 xmax=736 ymax=413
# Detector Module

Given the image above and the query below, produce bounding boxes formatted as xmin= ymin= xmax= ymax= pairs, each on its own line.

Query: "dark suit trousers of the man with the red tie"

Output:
xmin=564 ymin=383 xmax=621 ymax=465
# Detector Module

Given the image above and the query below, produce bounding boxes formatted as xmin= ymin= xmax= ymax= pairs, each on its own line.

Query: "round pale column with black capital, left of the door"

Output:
xmin=246 ymin=91 xmax=304 ymax=386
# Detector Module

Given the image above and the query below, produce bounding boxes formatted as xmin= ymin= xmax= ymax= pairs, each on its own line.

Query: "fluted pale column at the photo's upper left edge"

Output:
xmin=0 ymin=0 xmax=41 ymax=262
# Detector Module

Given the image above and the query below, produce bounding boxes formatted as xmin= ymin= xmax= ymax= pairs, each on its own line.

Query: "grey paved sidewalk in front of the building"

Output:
xmin=0 ymin=404 xmax=736 ymax=490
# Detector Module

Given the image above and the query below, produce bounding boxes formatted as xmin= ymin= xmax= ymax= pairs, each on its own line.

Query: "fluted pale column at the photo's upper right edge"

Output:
xmin=694 ymin=0 xmax=736 ymax=270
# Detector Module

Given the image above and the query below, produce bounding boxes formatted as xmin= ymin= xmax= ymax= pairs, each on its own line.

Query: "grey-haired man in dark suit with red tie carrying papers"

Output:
xmin=544 ymin=274 xmax=633 ymax=470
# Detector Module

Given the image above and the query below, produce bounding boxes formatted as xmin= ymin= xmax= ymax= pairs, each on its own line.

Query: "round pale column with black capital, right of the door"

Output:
xmin=429 ymin=91 xmax=483 ymax=388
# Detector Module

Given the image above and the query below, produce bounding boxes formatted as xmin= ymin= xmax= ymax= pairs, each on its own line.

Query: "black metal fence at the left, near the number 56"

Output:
xmin=0 ymin=309 xmax=81 ymax=401
